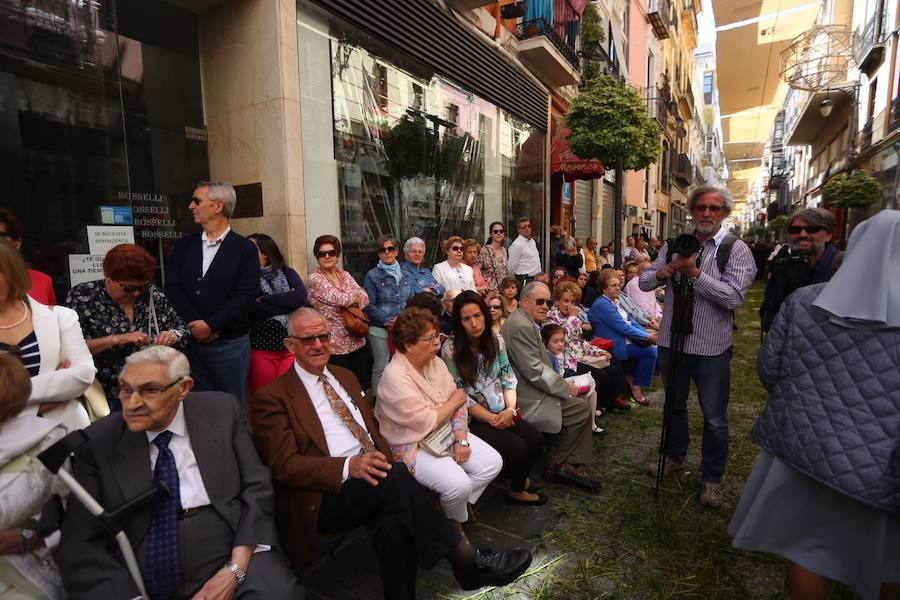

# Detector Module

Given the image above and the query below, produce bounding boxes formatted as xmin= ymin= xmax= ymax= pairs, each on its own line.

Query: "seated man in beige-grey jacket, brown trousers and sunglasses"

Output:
xmin=500 ymin=281 xmax=600 ymax=490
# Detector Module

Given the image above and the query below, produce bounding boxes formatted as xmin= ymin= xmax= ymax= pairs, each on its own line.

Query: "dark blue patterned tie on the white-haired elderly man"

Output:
xmin=145 ymin=431 xmax=181 ymax=600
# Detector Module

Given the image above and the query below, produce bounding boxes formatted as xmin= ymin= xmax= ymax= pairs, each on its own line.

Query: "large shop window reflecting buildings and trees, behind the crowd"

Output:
xmin=331 ymin=38 xmax=546 ymax=281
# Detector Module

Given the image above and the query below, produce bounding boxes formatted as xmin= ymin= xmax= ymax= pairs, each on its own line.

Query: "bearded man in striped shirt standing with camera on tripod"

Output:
xmin=640 ymin=185 xmax=756 ymax=507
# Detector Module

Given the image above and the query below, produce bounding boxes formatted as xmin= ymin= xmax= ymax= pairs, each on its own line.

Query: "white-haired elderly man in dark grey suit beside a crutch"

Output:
xmin=55 ymin=346 xmax=305 ymax=600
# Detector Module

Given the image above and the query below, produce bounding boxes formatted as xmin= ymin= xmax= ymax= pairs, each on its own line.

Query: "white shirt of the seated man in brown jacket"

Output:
xmin=294 ymin=362 xmax=374 ymax=481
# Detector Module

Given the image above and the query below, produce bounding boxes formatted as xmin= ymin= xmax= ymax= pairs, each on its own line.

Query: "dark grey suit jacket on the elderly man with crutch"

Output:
xmin=54 ymin=392 xmax=278 ymax=599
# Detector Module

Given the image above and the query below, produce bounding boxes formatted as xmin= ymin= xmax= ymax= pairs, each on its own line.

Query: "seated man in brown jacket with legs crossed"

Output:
xmin=251 ymin=308 xmax=531 ymax=600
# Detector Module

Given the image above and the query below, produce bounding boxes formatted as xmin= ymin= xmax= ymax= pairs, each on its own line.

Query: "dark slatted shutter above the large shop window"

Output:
xmin=312 ymin=0 xmax=548 ymax=131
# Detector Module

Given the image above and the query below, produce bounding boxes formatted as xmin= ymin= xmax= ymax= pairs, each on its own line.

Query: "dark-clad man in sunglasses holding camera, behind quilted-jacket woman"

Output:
xmin=759 ymin=208 xmax=844 ymax=332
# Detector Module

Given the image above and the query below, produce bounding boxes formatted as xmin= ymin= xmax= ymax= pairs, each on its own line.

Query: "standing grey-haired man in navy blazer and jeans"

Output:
xmin=166 ymin=181 xmax=261 ymax=403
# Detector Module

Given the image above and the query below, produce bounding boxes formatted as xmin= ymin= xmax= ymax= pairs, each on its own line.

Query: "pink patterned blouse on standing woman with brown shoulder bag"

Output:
xmin=306 ymin=267 xmax=369 ymax=354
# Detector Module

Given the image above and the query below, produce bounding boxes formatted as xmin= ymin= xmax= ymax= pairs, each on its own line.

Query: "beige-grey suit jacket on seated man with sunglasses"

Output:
xmin=500 ymin=308 xmax=569 ymax=433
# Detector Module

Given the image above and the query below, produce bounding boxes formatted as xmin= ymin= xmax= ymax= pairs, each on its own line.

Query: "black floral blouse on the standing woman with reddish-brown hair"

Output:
xmin=66 ymin=280 xmax=188 ymax=410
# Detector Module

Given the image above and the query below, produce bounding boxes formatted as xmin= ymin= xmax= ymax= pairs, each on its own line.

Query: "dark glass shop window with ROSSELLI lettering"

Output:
xmin=0 ymin=0 xmax=208 ymax=298
